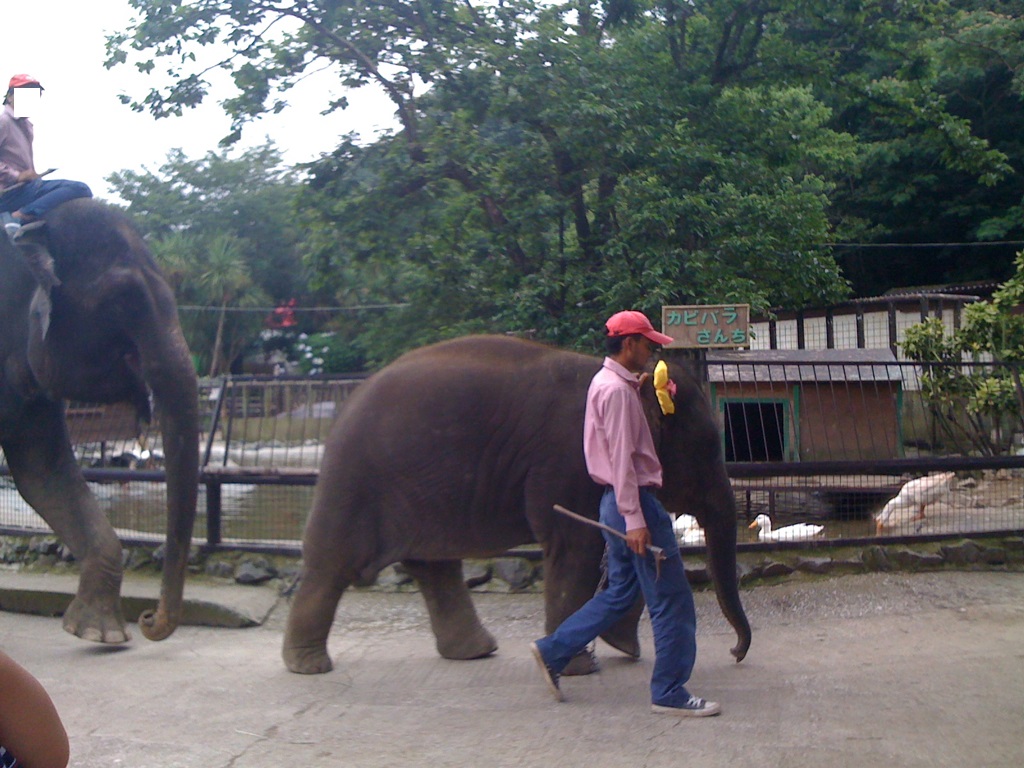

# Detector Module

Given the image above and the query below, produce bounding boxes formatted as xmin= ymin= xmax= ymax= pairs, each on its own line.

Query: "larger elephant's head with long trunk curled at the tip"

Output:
xmin=8 ymin=200 xmax=199 ymax=640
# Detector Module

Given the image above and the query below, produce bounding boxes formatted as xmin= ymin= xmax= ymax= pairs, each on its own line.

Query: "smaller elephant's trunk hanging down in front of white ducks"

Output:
xmin=698 ymin=468 xmax=751 ymax=662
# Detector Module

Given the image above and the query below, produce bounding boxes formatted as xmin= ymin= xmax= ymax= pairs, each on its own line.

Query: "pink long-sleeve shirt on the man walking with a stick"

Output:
xmin=583 ymin=357 xmax=662 ymax=530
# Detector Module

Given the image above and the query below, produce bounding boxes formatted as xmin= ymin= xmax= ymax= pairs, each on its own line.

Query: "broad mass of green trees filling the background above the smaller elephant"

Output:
xmin=108 ymin=0 xmax=1024 ymax=366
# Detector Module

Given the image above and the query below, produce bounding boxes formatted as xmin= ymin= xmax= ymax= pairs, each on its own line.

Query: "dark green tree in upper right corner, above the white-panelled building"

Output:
xmin=835 ymin=5 xmax=1024 ymax=295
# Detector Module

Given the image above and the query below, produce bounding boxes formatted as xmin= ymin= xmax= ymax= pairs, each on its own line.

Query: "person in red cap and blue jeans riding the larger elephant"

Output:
xmin=0 ymin=75 xmax=92 ymax=236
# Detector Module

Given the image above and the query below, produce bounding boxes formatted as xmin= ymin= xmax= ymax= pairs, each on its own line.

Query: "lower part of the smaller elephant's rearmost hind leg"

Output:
xmin=281 ymin=563 xmax=350 ymax=675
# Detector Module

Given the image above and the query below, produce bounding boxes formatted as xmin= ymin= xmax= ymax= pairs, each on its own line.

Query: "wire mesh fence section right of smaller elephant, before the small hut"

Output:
xmin=705 ymin=349 xmax=1024 ymax=542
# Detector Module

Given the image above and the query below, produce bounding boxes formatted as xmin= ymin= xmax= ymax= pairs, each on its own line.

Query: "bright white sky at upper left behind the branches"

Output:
xmin=0 ymin=0 xmax=394 ymax=200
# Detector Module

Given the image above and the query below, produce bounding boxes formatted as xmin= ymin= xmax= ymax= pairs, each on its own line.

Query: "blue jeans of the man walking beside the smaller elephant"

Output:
xmin=537 ymin=488 xmax=697 ymax=707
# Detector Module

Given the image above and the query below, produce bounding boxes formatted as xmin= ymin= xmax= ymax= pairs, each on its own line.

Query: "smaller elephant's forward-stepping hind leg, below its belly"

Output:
xmin=401 ymin=560 xmax=498 ymax=659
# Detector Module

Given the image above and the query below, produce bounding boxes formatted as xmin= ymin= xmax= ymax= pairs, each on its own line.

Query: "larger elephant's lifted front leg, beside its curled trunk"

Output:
xmin=3 ymin=400 xmax=130 ymax=643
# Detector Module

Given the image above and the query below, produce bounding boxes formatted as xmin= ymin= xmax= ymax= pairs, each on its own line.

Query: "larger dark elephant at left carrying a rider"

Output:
xmin=0 ymin=199 xmax=199 ymax=643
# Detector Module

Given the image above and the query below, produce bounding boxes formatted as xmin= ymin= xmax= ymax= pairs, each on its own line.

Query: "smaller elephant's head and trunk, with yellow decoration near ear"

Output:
xmin=641 ymin=362 xmax=751 ymax=662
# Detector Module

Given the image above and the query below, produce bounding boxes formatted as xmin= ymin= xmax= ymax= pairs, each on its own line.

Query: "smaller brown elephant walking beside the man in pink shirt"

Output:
xmin=282 ymin=336 xmax=751 ymax=674
